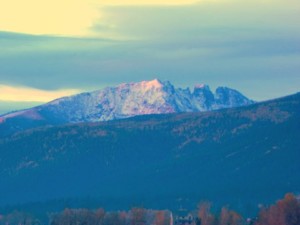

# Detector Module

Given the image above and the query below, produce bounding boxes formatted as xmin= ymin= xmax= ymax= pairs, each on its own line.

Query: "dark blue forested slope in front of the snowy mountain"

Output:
xmin=0 ymin=94 xmax=300 ymax=211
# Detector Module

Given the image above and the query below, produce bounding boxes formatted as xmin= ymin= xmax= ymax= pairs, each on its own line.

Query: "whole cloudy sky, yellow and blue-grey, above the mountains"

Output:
xmin=0 ymin=0 xmax=300 ymax=114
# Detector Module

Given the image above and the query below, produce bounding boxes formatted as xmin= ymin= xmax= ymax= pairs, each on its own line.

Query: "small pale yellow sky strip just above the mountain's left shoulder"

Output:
xmin=0 ymin=85 xmax=80 ymax=102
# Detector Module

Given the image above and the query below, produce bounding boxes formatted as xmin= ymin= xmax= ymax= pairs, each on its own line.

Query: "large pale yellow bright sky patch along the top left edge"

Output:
xmin=0 ymin=0 xmax=197 ymax=36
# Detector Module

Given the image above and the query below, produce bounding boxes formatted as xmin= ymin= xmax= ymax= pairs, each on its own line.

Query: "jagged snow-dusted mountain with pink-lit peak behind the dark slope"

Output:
xmin=0 ymin=79 xmax=253 ymax=136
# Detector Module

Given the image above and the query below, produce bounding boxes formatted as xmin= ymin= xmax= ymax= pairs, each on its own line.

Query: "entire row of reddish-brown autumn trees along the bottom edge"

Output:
xmin=0 ymin=194 xmax=300 ymax=225
